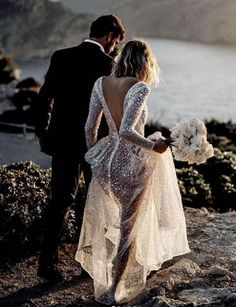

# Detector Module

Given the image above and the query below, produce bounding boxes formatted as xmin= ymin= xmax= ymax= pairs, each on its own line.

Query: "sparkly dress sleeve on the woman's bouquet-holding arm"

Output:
xmin=120 ymin=85 xmax=155 ymax=150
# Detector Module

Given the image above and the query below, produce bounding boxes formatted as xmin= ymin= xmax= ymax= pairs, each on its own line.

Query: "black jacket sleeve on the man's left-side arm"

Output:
xmin=35 ymin=53 xmax=56 ymax=138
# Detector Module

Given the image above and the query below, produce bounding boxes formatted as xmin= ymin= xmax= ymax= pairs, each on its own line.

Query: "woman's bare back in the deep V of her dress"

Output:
xmin=102 ymin=76 xmax=138 ymax=130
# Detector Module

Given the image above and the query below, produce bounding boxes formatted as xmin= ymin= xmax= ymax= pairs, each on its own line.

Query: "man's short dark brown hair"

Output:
xmin=89 ymin=15 xmax=125 ymax=41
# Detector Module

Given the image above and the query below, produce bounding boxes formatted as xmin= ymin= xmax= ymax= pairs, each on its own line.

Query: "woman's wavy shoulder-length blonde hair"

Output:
xmin=112 ymin=40 xmax=160 ymax=85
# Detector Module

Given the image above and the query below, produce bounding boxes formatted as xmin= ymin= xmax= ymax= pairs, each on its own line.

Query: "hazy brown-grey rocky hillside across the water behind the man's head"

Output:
xmin=0 ymin=0 xmax=236 ymax=58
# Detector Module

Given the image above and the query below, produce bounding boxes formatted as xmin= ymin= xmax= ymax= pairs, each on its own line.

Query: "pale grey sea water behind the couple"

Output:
xmin=20 ymin=38 xmax=236 ymax=127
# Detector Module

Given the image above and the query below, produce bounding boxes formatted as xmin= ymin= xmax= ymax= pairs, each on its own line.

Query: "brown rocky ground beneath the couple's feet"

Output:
xmin=0 ymin=208 xmax=236 ymax=307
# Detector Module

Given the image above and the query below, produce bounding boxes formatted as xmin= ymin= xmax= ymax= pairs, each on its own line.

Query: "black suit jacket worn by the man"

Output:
xmin=35 ymin=42 xmax=113 ymax=157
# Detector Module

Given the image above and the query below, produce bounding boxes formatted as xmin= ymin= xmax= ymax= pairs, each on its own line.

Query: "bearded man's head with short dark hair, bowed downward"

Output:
xmin=89 ymin=15 xmax=125 ymax=53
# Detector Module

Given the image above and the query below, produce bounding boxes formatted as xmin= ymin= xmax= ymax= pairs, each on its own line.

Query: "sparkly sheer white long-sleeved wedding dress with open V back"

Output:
xmin=76 ymin=78 xmax=189 ymax=304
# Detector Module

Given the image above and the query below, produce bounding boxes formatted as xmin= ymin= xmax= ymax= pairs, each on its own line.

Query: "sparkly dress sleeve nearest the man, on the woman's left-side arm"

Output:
xmin=85 ymin=82 xmax=103 ymax=149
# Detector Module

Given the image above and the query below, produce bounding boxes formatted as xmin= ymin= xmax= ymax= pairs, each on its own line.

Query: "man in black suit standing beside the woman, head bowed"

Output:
xmin=36 ymin=15 xmax=125 ymax=281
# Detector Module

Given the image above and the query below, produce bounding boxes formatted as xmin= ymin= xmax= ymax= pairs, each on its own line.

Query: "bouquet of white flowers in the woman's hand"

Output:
xmin=166 ymin=118 xmax=214 ymax=164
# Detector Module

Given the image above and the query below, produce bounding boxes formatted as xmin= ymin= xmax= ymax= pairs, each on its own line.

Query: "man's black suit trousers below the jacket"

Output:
xmin=39 ymin=155 xmax=91 ymax=266
